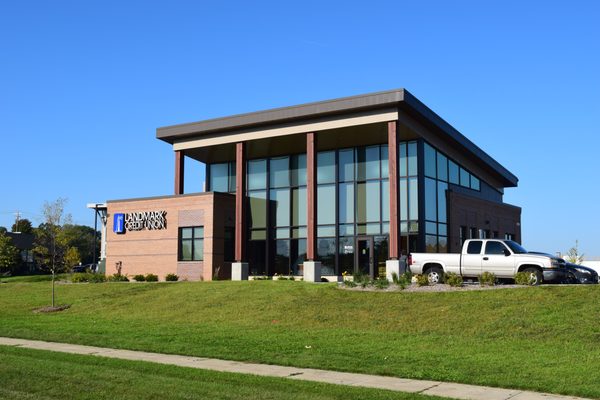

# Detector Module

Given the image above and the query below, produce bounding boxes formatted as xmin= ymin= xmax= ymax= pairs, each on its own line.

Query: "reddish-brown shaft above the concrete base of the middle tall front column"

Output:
xmin=306 ymin=133 xmax=317 ymax=261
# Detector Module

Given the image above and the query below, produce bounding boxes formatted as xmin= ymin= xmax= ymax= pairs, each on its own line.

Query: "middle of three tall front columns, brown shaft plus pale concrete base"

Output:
xmin=304 ymin=132 xmax=321 ymax=282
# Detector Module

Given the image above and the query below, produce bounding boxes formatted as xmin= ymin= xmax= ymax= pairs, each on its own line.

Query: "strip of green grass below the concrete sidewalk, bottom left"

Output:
xmin=0 ymin=346 xmax=435 ymax=400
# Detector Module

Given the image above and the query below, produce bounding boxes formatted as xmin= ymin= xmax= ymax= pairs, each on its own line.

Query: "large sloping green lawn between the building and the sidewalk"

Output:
xmin=0 ymin=281 xmax=600 ymax=398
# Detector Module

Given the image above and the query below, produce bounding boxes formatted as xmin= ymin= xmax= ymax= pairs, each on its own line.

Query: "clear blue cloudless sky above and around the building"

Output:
xmin=0 ymin=0 xmax=600 ymax=256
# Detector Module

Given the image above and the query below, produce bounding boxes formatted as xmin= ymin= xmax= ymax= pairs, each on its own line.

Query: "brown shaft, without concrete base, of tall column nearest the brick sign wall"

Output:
xmin=235 ymin=142 xmax=246 ymax=262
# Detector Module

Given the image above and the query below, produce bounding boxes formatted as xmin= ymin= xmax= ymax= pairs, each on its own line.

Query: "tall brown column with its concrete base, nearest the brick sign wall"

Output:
xmin=231 ymin=142 xmax=249 ymax=281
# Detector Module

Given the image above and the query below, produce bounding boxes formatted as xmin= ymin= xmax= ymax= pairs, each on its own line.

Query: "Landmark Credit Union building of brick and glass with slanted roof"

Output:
xmin=92 ymin=89 xmax=521 ymax=281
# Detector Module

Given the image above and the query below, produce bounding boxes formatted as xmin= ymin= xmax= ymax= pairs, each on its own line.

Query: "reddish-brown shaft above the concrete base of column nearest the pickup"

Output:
xmin=388 ymin=121 xmax=400 ymax=260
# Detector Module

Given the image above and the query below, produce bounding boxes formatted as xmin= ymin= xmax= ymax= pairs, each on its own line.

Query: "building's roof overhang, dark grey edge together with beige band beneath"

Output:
xmin=156 ymin=89 xmax=518 ymax=187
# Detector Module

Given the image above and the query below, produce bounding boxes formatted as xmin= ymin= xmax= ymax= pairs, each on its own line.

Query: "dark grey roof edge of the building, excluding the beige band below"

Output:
xmin=156 ymin=89 xmax=519 ymax=187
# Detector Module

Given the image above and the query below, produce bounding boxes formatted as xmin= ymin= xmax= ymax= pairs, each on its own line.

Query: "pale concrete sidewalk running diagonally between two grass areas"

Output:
xmin=0 ymin=337 xmax=582 ymax=400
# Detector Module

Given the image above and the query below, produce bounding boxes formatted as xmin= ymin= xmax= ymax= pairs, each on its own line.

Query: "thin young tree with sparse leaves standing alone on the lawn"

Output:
xmin=34 ymin=198 xmax=71 ymax=307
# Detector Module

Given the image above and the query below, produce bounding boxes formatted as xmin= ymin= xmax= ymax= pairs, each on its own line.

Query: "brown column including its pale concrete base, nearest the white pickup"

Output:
xmin=385 ymin=121 xmax=406 ymax=280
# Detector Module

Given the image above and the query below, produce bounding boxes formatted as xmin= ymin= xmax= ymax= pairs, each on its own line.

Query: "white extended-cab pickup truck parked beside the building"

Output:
xmin=408 ymin=239 xmax=568 ymax=285
